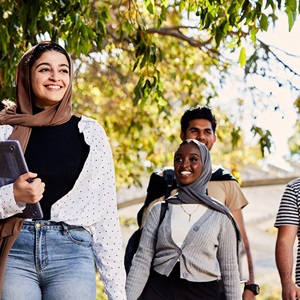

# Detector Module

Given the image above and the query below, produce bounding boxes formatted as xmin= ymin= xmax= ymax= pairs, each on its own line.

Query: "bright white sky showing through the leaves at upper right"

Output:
xmin=214 ymin=14 xmax=300 ymax=167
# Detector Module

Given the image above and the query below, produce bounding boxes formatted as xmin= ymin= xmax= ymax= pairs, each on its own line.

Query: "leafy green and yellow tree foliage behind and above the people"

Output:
xmin=0 ymin=0 xmax=300 ymax=184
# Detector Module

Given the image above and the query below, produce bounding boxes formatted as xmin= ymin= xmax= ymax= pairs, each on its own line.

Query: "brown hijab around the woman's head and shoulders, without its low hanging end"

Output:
xmin=0 ymin=41 xmax=73 ymax=152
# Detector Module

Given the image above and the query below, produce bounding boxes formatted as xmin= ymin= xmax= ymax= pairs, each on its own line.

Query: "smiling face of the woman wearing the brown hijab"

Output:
xmin=30 ymin=51 xmax=70 ymax=108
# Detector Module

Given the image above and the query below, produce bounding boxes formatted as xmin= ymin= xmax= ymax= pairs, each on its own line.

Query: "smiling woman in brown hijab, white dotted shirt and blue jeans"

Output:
xmin=0 ymin=41 xmax=126 ymax=300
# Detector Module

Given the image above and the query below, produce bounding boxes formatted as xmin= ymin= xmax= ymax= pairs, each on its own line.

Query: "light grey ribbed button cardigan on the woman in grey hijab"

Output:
xmin=126 ymin=203 xmax=241 ymax=300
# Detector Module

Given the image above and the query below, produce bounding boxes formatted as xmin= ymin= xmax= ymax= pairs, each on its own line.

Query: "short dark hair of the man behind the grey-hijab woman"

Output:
xmin=180 ymin=105 xmax=217 ymax=134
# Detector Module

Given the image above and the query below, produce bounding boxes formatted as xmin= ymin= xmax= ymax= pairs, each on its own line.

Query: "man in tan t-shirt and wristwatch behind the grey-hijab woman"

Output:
xmin=137 ymin=105 xmax=260 ymax=300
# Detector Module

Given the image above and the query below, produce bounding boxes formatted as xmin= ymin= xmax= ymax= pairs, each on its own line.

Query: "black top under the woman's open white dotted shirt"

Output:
xmin=25 ymin=116 xmax=89 ymax=220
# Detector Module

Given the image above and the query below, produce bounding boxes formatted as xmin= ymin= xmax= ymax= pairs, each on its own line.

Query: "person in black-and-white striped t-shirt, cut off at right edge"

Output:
xmin=274 ymin=178 xmax=300 ymax=300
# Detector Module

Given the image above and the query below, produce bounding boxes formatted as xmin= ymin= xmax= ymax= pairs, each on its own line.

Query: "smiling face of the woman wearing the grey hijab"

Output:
xmin=174 ymin=143 xmax=202 ymax=185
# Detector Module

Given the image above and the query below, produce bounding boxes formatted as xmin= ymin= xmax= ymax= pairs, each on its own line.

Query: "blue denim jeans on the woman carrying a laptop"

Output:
xmin=1 ymin=221 xmax=96 ymax=300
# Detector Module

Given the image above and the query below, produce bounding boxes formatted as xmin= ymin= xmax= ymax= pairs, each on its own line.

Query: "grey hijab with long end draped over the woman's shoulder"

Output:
xmin=166 ymin=140 xmax=249 ymax=282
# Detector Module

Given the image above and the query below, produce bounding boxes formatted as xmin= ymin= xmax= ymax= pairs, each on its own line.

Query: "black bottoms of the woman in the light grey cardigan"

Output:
xmin=139 ymin=263 xmax=220 ymax=300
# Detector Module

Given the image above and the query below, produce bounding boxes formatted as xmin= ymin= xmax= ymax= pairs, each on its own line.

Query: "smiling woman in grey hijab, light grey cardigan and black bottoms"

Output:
xmin=126 ymin=140 xmax=245 ymax=300
